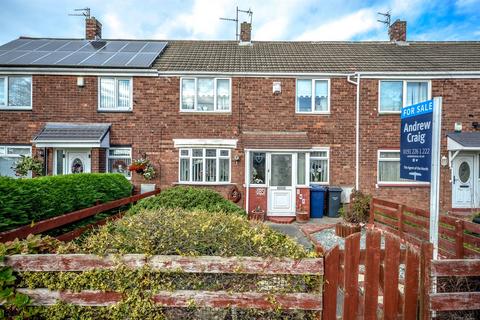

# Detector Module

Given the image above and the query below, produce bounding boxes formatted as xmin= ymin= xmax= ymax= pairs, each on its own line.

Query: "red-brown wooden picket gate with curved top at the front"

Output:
xmin=323 ymin=227 xmax=420 ymax=320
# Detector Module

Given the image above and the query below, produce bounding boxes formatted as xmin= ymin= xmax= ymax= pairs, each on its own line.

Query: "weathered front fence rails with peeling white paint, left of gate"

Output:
xmin=0 ymin=254 xmax=323 ymax=318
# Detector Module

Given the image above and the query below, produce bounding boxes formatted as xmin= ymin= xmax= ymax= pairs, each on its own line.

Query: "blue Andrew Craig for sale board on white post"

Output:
xmin=400 ymin=100 xmax=433 ymax=182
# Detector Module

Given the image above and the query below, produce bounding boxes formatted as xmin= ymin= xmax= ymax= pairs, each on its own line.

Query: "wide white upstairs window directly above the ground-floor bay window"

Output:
xmin=180 ymin=78 xmax=231 ymax=112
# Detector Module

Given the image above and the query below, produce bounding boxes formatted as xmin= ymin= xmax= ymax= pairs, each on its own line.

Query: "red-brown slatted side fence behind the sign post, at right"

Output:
xmin=369 ymin=198 xmax=480 ymax=259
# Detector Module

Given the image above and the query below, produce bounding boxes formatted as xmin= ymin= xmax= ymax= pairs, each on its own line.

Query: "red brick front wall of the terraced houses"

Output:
xmin=0 ymin=75 xmax=480 ymax=211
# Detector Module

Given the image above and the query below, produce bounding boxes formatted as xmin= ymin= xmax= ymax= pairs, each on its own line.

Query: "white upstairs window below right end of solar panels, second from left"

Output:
xmin=98 ymin=77 xmax=133 ymax=111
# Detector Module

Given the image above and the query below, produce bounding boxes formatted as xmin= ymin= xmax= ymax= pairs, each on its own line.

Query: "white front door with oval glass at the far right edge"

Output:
xmin=452 ymin=155 xmax=475 ymax=208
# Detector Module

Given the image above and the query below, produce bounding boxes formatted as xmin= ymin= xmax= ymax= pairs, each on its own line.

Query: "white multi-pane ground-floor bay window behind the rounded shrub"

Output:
xmin=179 ymin=148 xmax=230 ymax=184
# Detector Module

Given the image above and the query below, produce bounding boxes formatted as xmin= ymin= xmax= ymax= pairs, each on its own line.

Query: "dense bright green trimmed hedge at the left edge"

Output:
xmin=0 ymin=173 xmax=132 ymax=231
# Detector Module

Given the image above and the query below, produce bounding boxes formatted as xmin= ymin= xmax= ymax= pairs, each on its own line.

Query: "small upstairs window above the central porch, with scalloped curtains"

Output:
xmin=296 ymin=79 xmax=330 ymax=114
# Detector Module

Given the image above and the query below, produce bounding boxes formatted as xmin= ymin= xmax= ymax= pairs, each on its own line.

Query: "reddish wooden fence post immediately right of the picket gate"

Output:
xmin=419 ymin=242 xmax=433 ymax=320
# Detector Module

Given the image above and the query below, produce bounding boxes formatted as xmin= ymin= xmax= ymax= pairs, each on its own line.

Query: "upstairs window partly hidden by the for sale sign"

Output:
xmin=379 ymin=80 xmax=430 ymax=113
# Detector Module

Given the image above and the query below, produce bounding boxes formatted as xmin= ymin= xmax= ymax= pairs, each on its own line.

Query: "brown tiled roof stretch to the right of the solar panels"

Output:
xmin=154 ymin=40 xmax=480 ymax=73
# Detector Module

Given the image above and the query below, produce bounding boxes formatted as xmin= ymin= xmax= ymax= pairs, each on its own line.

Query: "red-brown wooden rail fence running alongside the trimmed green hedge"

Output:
xmin=0 ymin=189 xmax=160 ymax=242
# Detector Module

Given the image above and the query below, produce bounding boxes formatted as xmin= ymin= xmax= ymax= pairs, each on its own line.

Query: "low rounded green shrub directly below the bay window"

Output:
xmin=130 ymin=187 xmax=246 ymax=215
